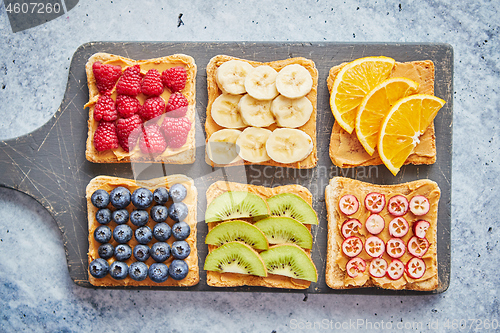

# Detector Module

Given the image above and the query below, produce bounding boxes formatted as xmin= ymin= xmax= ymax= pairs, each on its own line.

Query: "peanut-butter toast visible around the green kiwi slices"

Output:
xmin=207 ymin=181 xmax=312 ymax=289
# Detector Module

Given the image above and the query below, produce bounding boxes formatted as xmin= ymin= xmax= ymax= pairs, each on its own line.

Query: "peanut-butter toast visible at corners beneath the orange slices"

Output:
xmin=327 ymin=60 xmax=436 ymax=168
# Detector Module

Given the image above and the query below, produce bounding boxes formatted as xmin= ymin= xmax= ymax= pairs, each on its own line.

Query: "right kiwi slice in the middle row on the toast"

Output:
xmin=254 ymin=217 xmax=312 ymax=249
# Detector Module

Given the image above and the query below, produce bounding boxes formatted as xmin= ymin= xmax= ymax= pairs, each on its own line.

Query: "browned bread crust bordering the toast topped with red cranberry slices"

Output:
xmin=325 ymin=177 xmax=440 ymax=291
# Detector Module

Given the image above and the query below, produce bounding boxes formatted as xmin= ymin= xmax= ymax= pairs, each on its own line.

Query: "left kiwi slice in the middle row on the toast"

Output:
xmin=205 ymin=221 xmax=270 ymax=250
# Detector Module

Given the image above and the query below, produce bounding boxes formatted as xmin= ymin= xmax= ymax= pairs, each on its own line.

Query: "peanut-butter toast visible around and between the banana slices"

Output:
xmin=205 ymin=55 xmax=318 ymax=169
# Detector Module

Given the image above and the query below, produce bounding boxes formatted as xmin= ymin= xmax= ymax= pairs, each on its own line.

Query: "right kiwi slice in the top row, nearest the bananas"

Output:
xmin=267 ymin=193 xmax=318 ymax=224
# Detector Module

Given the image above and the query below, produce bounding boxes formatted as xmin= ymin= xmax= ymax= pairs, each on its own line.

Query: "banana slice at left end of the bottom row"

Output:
xmin=206 ymin=128 xmax=241 ymax=164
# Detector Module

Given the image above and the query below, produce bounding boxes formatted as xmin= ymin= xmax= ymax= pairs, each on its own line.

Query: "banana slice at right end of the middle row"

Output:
xmin=271 ymin=95 xmax=313 ymax=128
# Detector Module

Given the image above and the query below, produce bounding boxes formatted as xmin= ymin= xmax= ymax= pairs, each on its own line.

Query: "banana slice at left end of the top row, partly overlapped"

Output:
xmin=215 ymin=60 xmax=253 ymax=95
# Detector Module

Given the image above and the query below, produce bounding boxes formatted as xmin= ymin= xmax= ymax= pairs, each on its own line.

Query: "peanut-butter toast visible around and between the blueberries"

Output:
xmin=86 ymin=175 xmax=200 ymax=287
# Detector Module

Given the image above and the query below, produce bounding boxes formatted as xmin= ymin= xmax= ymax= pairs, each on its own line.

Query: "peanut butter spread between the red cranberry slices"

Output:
xmin=335 ymin=182 xmax=440 ymax=289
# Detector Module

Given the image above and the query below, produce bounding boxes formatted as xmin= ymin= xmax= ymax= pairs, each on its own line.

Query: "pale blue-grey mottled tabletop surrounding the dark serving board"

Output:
xmin=0 ymin=0 xmax=500 ymax=332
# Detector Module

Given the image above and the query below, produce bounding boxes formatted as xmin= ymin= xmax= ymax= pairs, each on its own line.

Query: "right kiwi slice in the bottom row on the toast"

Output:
xmin=260 ymin=244 xmax=318 ymax=282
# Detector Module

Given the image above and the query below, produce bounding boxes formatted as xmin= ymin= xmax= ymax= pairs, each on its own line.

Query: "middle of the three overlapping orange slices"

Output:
xmin=355 ymin=77 xmax=418 ymax=156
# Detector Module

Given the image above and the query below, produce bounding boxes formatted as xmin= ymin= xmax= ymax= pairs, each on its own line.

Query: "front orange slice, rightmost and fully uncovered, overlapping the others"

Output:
xmin=377 ymin=94 xmax=446 ymax=176
